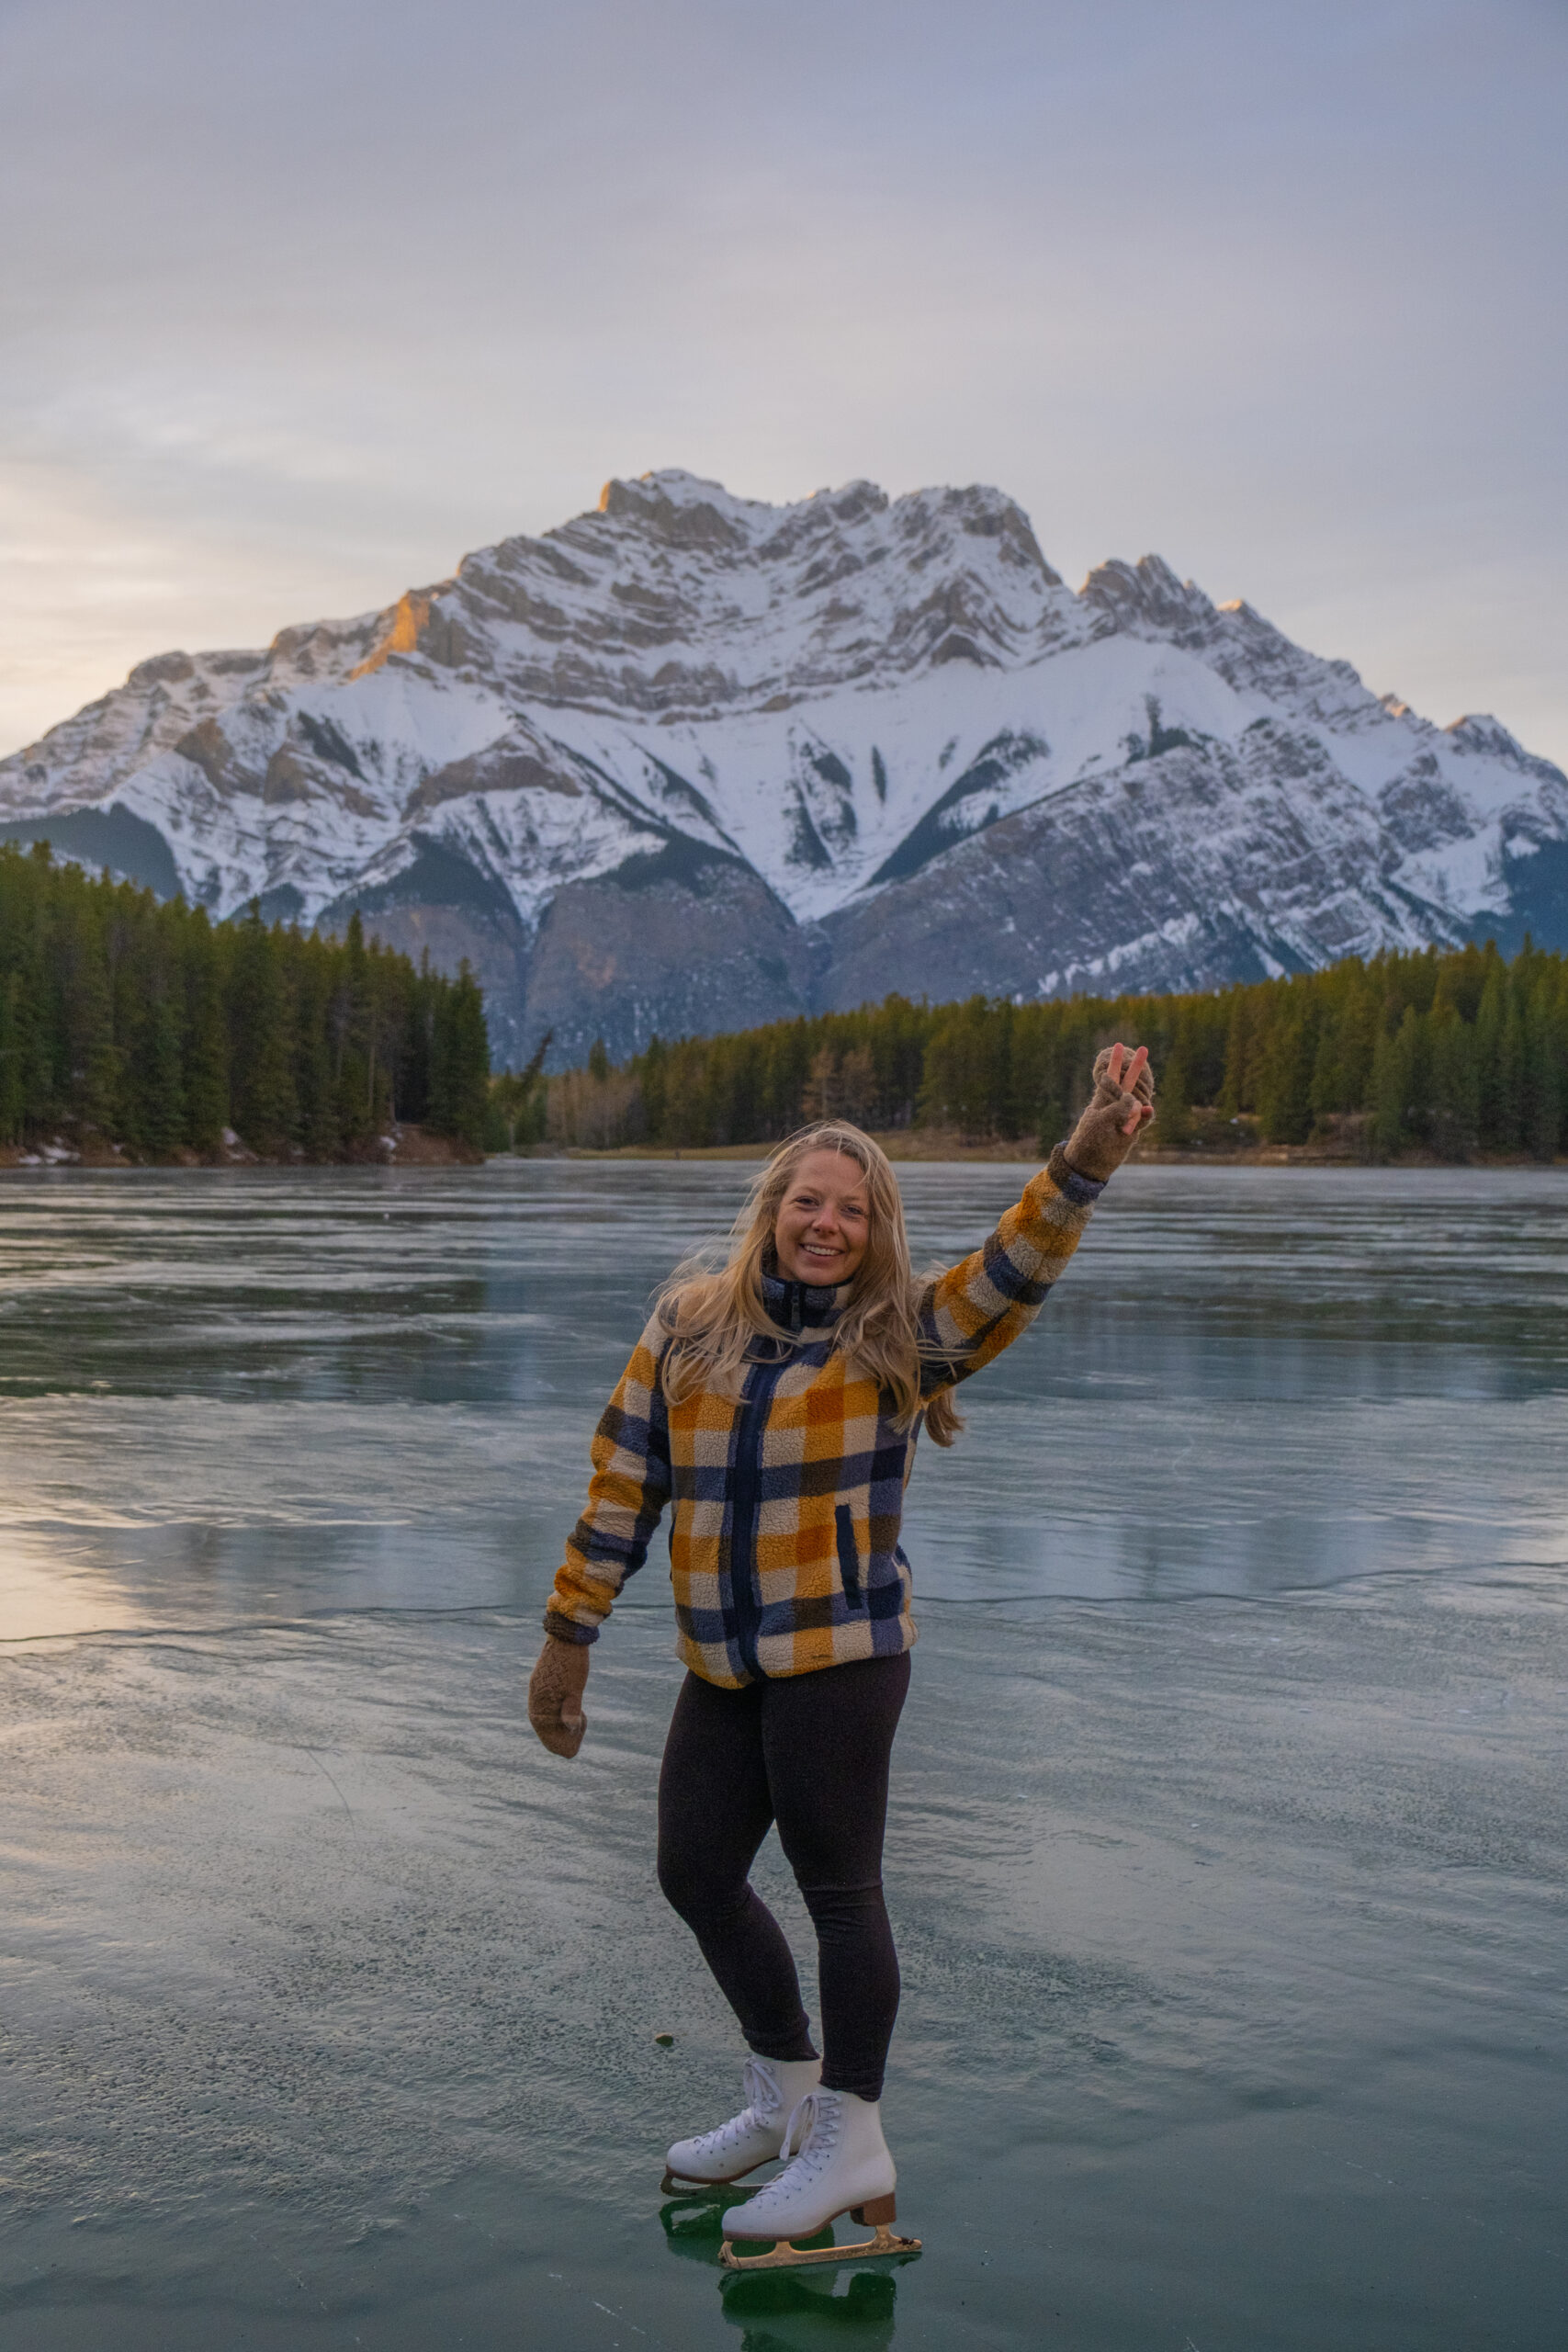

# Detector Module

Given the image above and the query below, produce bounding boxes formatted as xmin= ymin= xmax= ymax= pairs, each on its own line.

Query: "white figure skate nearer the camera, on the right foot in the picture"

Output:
xmin=719 ymin=2088 xmax=919 ymax=2269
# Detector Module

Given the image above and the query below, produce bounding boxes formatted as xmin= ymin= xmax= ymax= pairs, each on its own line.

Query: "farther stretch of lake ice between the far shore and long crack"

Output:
xmin=0 ymin=1162 xmax=1568 ymax=1623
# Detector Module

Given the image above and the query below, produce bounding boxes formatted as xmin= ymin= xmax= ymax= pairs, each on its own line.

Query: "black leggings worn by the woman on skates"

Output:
xmin=659 ymin=1654 xmax=909 ymax=2098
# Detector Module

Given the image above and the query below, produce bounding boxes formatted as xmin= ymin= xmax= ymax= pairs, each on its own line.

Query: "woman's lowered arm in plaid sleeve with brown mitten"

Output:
xmin=529 ymin=1322 xmax=670 ymax=1757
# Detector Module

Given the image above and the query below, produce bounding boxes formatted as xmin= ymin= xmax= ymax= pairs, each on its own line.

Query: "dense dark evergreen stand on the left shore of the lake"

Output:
xmin=0 ymin=842 xmax=489 ymax=1159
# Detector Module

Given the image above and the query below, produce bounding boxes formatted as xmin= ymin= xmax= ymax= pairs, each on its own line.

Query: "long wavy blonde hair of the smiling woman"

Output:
xmin=659 ymin=1120 xmax=964 ymax=1446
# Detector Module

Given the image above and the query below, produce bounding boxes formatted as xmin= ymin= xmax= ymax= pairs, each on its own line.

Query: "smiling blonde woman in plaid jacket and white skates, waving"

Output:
xmin=529 ymin=1045 xmax=1155 ymax=2239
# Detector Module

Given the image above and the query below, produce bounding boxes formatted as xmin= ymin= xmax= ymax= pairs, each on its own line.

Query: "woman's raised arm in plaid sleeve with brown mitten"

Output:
xmin=919 ymin=1045 xmax=1155 ymax=1395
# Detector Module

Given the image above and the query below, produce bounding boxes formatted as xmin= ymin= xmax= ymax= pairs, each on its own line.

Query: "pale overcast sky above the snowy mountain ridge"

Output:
xmin=0 ymin=0 xmax=1568 ymax=762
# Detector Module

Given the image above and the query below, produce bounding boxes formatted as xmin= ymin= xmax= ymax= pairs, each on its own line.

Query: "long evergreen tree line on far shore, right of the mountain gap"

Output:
xmin=533 ymin=941 xmax=1568 ymax=1159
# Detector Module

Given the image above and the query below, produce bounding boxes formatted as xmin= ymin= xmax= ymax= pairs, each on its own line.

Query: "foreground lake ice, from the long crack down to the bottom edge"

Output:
xmin=0 ymin=1578 xmax=1568 ymax=2352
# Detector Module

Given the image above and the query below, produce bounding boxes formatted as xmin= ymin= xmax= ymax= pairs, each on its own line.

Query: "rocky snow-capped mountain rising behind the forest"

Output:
xmin=0 ymin=473 xmax=1568 ymax=1063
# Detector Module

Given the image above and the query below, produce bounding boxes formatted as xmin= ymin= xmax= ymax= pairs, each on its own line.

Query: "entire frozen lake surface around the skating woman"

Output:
xmin=0 ymin=1162 xmax=1568 ymax=2352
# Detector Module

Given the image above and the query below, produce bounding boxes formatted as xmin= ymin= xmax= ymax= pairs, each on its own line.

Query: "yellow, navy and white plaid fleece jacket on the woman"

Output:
xmin=546 ymin=1146 xmax=1105 ymax=1691
